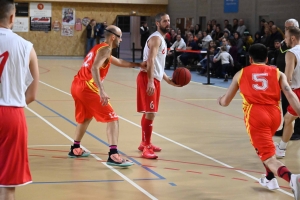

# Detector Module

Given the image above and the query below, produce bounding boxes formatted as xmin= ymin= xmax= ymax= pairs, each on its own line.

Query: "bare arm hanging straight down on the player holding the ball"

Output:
xmin=147 ymin=36 xmax=161 ymax=96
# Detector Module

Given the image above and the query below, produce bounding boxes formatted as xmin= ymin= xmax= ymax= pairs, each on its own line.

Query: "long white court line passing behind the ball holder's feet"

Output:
xmin=40 ymin=81 xmax=294 ymax=197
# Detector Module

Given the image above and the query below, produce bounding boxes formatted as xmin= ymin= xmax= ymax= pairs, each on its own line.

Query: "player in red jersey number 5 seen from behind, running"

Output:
xmin=218 ymin=44 xmax=300 ymax=200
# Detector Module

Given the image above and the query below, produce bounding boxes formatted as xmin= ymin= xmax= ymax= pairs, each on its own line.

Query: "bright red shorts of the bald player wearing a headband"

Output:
xmin=71 ymin=78 xmax=118 ymax=123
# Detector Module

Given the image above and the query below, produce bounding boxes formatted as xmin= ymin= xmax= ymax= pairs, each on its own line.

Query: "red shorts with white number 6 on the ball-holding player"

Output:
xmin=136 ymin=71 xmax=160 ymax=113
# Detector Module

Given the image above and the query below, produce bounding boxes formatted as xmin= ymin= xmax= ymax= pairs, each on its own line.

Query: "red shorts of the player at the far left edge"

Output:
xmin=0 ymin=106 xmax=32 ymax=187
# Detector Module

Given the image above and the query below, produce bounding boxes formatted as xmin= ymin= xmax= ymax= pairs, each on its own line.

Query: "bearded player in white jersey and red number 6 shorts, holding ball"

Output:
xmin=137 ymin=13 xmax=178 ymax=159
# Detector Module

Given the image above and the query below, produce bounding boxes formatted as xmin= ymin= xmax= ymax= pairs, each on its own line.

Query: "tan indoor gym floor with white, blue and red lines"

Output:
xmin=16 ymin=59 xmax=300 ymax=200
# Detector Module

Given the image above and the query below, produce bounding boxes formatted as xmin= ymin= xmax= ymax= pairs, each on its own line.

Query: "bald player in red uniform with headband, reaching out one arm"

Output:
xmin=69 ymin=25 xmax=146 ymax=166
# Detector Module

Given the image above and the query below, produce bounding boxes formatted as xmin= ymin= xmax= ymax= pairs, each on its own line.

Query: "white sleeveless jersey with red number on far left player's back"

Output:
xmin=0 ymin=28 xmax=33 ymax=107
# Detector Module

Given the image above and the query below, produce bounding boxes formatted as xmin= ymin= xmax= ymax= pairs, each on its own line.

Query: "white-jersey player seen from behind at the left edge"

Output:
xmin=0 ymin=0 xmax=39 ymax=200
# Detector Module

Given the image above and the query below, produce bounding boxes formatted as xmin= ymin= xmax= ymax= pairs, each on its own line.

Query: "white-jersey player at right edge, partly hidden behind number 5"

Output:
xmin=276 ymin=26 xmax=300 ymax=158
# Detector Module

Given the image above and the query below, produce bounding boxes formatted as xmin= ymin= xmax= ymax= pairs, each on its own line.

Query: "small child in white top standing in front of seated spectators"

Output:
xmin=213 ymin=46 xmax=234 ymax=81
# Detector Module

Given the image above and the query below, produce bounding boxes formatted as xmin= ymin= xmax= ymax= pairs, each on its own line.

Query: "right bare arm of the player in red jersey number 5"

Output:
xmin=279 ymin=72 xmax=300 ymax=116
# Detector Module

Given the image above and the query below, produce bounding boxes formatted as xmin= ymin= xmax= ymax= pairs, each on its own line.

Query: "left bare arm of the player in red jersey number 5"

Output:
xmin=218 ymin=71 xmax=241 ymax=107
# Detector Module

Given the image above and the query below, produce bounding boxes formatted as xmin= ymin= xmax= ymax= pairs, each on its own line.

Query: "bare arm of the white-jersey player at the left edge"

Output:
xmin=25 ymin=48 xmax=39 ymax=105
